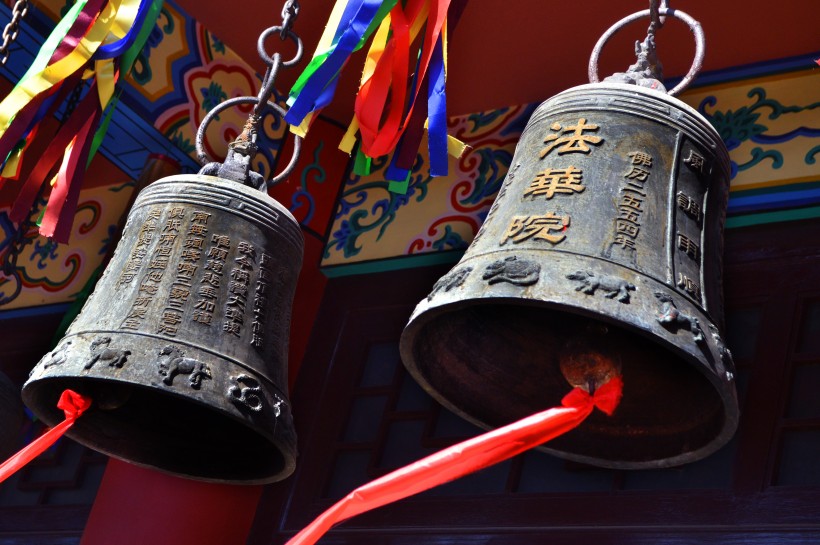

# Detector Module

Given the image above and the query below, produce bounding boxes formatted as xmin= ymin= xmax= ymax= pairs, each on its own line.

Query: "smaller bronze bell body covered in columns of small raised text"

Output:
xmin=23 ymin=175 xmax=303 ymax=483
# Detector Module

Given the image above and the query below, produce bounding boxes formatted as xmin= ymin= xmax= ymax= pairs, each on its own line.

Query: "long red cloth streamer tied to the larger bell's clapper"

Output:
xmin=287 ymin=377 xmax=623 ymax=545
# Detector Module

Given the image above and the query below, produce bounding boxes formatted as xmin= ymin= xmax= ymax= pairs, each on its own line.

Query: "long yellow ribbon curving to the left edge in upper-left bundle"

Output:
xmin=0 ymin=0 xmax=122 ymax=130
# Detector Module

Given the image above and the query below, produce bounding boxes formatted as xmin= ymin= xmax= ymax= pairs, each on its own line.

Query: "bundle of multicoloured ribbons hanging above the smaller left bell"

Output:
xmin=0 ymin=0 xmax=162 ymax=242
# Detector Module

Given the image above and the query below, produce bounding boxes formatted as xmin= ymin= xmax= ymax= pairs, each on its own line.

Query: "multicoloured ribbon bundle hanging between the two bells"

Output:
xmin=285 ymin=0 xmax=465 ymax=190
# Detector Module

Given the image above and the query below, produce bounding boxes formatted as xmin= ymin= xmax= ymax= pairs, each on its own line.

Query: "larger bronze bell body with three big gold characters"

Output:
xmin=401 ymin=83 xmax=738 ymax=469
